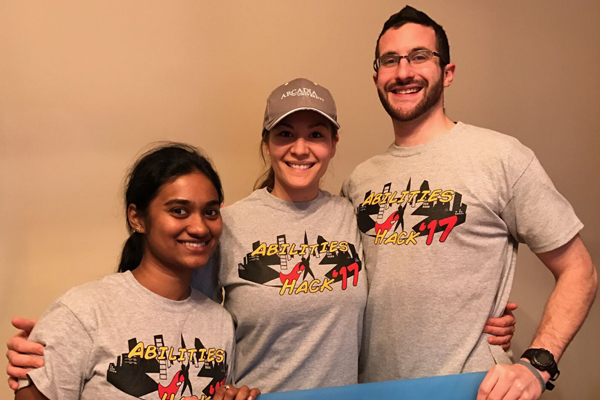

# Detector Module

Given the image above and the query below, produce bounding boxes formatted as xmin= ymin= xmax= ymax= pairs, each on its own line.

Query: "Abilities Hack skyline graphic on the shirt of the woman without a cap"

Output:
xmin=106 ymin=335 xmax=228 ymax=400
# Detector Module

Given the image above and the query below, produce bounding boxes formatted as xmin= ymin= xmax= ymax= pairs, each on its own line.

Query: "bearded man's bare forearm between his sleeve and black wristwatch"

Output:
xmin=531 ymin=241 xmax=598 ymax=361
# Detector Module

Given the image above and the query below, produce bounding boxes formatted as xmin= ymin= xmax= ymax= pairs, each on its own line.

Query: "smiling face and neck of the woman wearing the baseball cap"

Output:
xmin=263 ymin=110 xmax=339 ymax=202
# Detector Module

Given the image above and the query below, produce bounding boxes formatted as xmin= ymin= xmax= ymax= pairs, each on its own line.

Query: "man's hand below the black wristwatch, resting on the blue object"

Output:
xmin=477 ymin=364 xmax=549 ymax=400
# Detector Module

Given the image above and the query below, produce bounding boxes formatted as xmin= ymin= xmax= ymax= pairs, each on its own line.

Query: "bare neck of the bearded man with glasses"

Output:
xmin=392 ymin=104 xmax=454 ymax=147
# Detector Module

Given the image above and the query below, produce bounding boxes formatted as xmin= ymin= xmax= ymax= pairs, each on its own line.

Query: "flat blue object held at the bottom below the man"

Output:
xmin=257 ymin=372 xmax=486 ymax=400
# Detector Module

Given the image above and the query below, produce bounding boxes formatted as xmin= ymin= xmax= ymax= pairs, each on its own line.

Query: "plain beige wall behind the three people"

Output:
xmin=0 ymin=0 xmax=600 ymax=400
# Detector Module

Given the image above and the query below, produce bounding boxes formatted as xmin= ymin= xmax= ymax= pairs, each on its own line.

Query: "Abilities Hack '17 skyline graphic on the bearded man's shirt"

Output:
xmin=356 ymin=179 xmax=467 ymax=245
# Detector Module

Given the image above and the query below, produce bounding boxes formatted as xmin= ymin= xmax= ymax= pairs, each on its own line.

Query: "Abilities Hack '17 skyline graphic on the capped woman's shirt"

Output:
xmin=238 ymin=232 xmax=362 ymax=296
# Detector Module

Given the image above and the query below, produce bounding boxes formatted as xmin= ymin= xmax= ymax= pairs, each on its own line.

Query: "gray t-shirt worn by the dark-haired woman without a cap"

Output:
xmin=20 ymin=272 xmax=234 ymax=400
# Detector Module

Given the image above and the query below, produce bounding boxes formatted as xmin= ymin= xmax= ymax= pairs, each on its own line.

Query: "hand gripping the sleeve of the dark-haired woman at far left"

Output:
xmin=6 ymin=318 xmax=44 ymax=390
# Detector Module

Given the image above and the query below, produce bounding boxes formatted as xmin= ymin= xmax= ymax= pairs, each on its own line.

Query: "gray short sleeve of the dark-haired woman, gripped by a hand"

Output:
xmin=19 ymin=301 xmax=92 ymax=400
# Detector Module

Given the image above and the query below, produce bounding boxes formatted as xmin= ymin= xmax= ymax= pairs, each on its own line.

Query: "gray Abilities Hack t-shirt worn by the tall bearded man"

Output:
xmin=342 ymin=122 xmax=583 ymax=382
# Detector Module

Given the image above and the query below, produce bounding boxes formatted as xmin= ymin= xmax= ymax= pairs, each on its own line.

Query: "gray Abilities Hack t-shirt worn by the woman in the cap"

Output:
xmin=219 ymin=189 xmax=367 ymax=392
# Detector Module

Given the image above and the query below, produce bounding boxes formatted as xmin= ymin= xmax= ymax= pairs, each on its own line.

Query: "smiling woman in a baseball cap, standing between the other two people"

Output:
xmin=214 ymin=79 xmax=367 ymax=392
